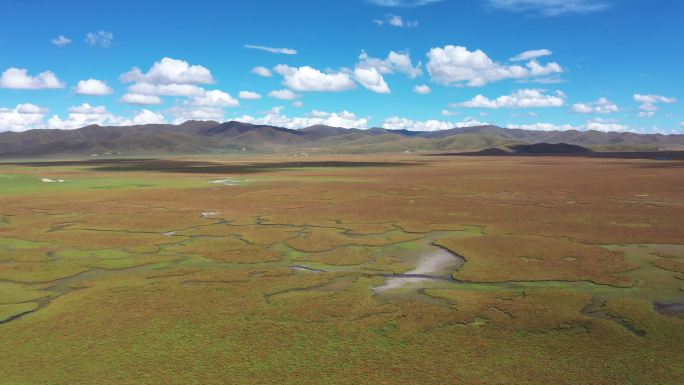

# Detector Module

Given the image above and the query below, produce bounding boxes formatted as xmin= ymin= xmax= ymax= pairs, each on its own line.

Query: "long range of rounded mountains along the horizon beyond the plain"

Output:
xmin=0 ymin=121 xmax=684 ymax=158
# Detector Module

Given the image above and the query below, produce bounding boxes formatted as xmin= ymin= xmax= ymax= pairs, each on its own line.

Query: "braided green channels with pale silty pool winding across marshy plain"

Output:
xmin=0 ymin=216 xmax=684 ymax=336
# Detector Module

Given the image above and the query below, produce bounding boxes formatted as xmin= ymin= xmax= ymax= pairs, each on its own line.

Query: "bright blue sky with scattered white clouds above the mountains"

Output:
xmin=0 ymin=0 xmax=684 ymax=133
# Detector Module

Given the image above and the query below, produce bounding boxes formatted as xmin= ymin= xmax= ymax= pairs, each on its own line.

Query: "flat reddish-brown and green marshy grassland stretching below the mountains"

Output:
xmin=0 ymin=155 xmax=684 ymax=385
